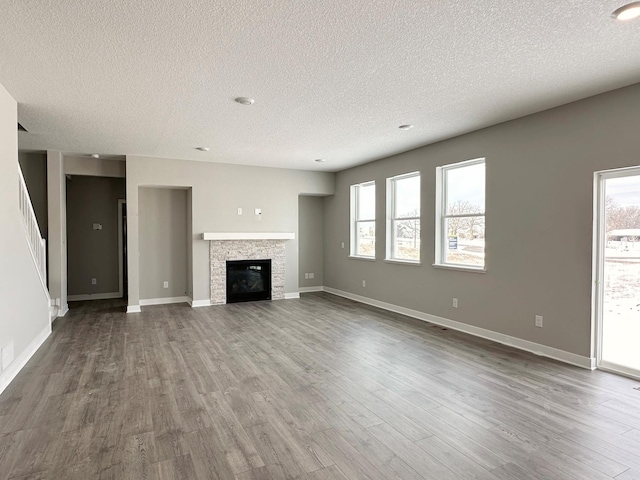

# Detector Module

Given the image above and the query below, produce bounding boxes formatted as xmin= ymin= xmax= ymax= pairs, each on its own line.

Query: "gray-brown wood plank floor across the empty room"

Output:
xmin=0 ymin=294 xmax=640 ymax=480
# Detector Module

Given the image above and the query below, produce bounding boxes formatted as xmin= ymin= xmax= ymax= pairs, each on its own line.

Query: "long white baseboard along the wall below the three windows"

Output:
xmin=323 ymin=287 xmax=596 ymax=370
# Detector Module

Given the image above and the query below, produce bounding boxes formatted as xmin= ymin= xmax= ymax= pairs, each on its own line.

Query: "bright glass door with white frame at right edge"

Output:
xmin=594 ymin=167 xmax=640 ymax=379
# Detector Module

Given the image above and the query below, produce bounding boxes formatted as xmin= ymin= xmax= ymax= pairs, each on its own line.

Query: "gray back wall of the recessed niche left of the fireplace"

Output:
xmin=138 ymin=188 xmax=191 ymax=299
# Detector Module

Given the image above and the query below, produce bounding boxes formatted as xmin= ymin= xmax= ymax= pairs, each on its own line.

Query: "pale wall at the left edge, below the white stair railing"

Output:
xmin=0 ymin=85 xmax=51 ymax=391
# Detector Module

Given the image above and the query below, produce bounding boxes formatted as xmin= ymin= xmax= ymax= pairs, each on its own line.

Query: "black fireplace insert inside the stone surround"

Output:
xmin=227 ymin=259 xmax=271 ymax=303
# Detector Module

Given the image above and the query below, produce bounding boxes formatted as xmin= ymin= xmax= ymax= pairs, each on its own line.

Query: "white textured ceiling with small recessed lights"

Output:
xmin=0 ymin=0 xmax=640 ymax=171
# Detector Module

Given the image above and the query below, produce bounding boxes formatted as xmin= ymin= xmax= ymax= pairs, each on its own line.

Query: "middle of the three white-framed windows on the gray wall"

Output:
xmin=387 ymin=172 xmax=420 ymax=262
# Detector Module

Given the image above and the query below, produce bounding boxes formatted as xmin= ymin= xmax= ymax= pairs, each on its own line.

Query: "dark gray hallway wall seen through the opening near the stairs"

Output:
xmin=65 ymin=176 xmax=125 ymax=296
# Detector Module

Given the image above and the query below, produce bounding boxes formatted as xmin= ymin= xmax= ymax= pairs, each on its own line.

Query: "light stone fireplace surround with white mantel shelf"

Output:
xmin=203 ymin=233 xmax=294 ymax=305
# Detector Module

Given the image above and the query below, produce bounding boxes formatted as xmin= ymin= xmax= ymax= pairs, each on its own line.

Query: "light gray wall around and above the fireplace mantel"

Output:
xmin=127 ymin=156 xmax=335 ymax=306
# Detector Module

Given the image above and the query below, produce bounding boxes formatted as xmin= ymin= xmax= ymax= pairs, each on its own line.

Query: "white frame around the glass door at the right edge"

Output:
xmin=591 ymin=166 xmax=640 ymax=380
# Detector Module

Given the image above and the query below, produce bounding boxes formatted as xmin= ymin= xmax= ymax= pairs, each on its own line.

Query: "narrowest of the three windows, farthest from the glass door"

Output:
xmin=351 ymin=182 xmax=376 ymax=258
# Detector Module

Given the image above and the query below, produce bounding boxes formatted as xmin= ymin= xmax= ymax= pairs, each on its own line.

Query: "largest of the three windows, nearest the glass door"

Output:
xmin=436 ymin=158 xmax=485 ymax=270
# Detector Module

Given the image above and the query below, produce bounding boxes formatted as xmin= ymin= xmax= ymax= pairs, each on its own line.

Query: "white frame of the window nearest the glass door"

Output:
xmin=433 ymin=157 xmax=487 ymax=273
